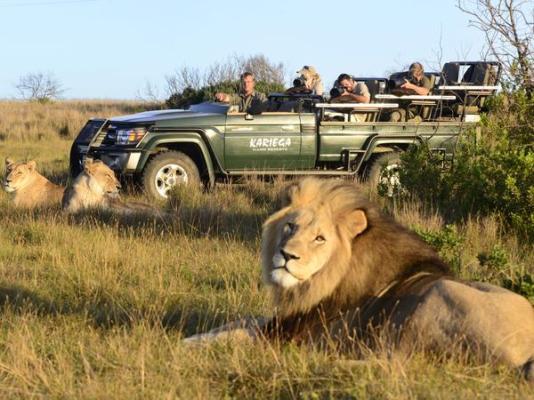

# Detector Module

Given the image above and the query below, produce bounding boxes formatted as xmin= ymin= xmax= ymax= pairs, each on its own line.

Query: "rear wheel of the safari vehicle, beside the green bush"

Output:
xmin=369 ymin=152 xmax=403 ymax=197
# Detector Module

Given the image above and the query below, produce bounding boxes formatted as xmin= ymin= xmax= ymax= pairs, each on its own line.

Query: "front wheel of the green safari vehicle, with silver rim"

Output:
xmin=142 ymin=151 xmax=200 ymax=200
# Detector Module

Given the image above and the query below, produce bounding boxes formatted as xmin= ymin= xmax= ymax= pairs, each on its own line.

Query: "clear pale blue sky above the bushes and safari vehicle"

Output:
xmin=0 ymin=0 xmax=483 ymax=99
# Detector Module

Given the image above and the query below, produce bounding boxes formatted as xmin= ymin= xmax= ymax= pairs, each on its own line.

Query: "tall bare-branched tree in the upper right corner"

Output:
xmin=457 ymin=0 xmax=534 ymax=97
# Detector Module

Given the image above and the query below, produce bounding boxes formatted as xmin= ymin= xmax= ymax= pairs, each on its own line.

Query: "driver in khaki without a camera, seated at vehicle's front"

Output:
xmin=215 ymin=72 xmax=267 ymax=114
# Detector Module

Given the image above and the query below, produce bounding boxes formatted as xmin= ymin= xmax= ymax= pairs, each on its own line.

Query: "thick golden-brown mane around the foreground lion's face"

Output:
xmin=262 ymin=178 xmax=449 ymax=324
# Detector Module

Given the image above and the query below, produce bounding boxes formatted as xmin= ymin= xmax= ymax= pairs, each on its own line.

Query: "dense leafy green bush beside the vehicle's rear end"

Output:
xmin=400 ymin=92 xmax=534 ymax=240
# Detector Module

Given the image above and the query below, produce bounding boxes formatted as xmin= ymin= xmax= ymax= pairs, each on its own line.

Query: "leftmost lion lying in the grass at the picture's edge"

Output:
xmin=2 ymin=158 xmax=65 ymax=208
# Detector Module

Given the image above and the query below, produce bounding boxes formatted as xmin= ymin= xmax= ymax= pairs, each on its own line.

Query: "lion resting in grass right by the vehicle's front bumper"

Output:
xmin=63 ymin=158 xmax=156 ymax=214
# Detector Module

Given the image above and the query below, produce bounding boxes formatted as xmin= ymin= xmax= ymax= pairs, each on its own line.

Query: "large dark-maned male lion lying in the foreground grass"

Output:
xmin=188 ymin=178 xmax=534 ymax=381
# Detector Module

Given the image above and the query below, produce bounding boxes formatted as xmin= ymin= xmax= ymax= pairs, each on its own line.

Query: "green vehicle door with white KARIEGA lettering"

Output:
xmin=224 ymin=112 xmax=302 ymax=171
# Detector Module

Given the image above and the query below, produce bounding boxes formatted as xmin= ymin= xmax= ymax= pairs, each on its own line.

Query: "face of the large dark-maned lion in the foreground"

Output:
xmin=262 ymin=179 xmax=367 ymax=290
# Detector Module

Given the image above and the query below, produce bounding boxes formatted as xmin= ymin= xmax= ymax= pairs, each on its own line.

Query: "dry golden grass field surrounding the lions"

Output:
xmin=0 ymin=102 xmax=534 ymax=399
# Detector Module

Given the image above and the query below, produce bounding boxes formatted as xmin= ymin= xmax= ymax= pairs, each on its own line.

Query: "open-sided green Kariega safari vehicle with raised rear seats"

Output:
xmin=71 ymin=62 xmax=498 ymax=198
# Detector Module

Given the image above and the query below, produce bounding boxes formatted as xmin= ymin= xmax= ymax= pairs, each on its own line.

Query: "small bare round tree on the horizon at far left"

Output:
xmin=16 ymin=72 xmax=65 ymax=103
